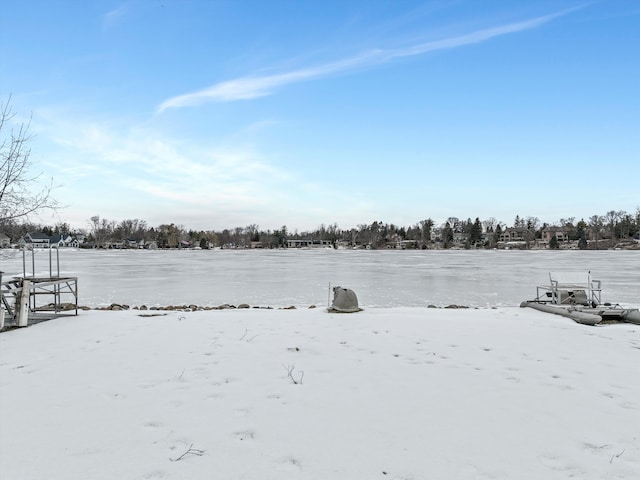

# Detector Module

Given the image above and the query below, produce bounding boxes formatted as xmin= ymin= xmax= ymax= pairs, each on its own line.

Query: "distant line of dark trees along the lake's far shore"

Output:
xmin=0 ymin=206 xmax=640 ymax=249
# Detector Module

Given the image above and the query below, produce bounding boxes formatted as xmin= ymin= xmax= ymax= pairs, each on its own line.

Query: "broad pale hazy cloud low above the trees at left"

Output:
xmin=37 ymin=109 xmax=370 ymax=228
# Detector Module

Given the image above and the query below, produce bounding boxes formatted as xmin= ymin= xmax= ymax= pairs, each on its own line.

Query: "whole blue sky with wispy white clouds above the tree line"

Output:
xmin=0 ymin=0 xmax=640 ymax=230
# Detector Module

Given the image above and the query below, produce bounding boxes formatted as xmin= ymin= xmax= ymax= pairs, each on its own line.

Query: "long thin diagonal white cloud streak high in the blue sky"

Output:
xmin=157 ymin=7 xmax=582 ymax=113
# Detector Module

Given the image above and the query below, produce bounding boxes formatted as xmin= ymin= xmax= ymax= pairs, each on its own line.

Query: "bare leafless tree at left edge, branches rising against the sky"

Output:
xmin=0 ymin=98 xmax=58 ymax=224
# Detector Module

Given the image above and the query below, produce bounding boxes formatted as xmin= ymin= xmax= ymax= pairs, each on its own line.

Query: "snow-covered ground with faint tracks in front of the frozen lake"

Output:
xmin=0 ymin=306 xmax=640 ymax=480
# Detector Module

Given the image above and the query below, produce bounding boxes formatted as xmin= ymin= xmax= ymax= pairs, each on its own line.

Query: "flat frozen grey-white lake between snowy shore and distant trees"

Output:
xmin=0 ymin=249 xmax=640 ymax=308
